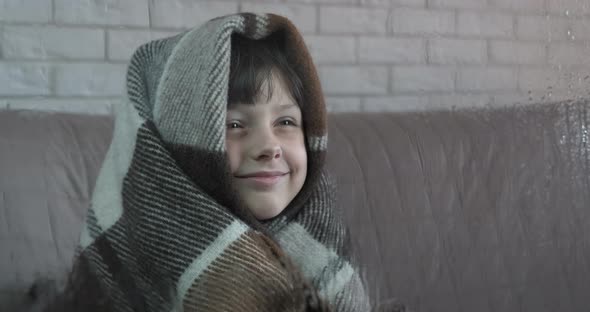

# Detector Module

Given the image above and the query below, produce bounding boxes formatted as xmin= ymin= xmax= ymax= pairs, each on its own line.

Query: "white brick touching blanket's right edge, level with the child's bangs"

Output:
xmin=319 ymin=66 xmax=389 ymax=95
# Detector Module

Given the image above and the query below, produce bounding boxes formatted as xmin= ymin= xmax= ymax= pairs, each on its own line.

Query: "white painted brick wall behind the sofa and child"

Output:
xmin=0 ymin=0 xmax=590 ymax=114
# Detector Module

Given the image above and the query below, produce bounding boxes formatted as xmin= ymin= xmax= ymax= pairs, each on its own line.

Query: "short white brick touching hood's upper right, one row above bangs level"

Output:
xmin=305 ymin=36 xmax=356 ymax=64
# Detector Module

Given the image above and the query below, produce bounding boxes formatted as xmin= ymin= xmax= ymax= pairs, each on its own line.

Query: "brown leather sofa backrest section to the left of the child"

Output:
xmin=0 ymin=111 xmax=112 ymax=291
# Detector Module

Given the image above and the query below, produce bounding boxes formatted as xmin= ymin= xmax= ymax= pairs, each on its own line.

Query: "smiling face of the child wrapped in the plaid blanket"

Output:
xmin=226 ymin=76 xmax=307 ymax=220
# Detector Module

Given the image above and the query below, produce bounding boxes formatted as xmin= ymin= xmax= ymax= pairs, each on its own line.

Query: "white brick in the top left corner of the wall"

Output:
xmin=0 ymin=0 xmax=52 ymax=23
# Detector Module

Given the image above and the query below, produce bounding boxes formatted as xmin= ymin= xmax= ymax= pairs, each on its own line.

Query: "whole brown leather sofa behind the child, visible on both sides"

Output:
xmin=0 ymin=101 xmax=590 ymax=312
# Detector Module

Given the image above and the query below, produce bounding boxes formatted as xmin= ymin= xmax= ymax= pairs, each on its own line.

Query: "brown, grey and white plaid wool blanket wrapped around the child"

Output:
xmin=53 ymin=13 xmax=369 ymax=311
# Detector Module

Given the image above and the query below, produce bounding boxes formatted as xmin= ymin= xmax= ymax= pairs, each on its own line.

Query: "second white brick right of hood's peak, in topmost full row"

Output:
xmin=391 ymin=9 xmax=455 ymax=35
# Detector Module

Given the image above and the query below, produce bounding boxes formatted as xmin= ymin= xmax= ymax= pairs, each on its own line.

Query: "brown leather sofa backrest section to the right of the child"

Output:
xmin=328 ymin=102 xmax=590 ymax=311
